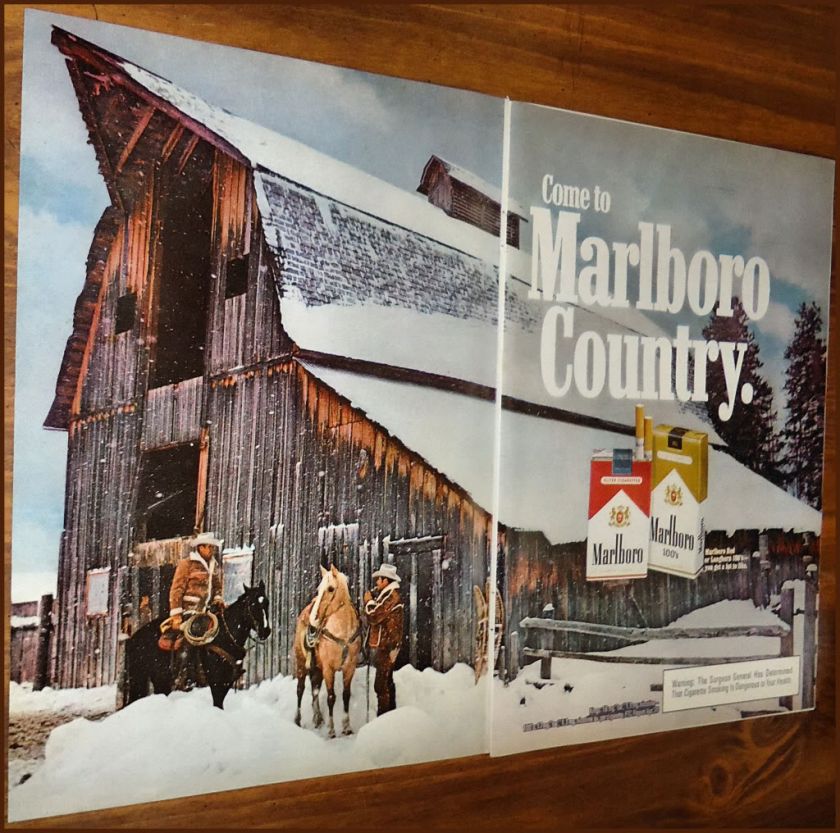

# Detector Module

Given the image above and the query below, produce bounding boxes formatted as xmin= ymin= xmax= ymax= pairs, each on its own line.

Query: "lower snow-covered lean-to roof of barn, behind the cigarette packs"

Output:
xmin=303 ymin=362 xmax=821 ymax=544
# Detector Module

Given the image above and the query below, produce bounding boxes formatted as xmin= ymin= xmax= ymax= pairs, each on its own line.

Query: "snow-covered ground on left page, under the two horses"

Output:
xmin=9 ymin=665 xmax=487 ymax=820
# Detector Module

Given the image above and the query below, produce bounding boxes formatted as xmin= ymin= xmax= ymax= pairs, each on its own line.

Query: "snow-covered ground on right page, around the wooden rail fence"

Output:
xmin=491 ymin=596 xmax=803 ymax=754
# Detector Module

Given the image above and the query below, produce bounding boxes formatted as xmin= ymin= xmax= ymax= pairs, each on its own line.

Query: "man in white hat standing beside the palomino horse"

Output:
xmin=364 ymin=564 xmax=403 ymax=715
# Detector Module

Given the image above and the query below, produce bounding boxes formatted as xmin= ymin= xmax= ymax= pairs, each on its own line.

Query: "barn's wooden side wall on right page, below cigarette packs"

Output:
xmin=499 ymin=530 xmax=819 ymax=663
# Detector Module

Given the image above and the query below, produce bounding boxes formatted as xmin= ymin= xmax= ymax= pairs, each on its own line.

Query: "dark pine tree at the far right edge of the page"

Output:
xmin=784 ymin=302 xmax=825 ymax=509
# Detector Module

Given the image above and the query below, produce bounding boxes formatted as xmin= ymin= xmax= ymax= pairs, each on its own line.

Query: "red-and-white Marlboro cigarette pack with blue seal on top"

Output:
xmin=586 ymin=448 xmax=651 ymax=581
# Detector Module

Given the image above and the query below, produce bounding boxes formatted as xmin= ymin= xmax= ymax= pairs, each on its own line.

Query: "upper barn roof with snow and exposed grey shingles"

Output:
xmin=47 ymin=27 xmax=719 ymax=442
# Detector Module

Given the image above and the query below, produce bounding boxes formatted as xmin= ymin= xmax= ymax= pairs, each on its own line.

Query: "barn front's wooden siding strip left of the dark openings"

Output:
xmin=56 ymin=163 xmax=160 ymax=687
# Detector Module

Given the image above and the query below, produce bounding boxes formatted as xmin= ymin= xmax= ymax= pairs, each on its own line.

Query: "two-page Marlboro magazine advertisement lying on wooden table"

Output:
xmin=8 ymin=12 xmax=833 ymax=820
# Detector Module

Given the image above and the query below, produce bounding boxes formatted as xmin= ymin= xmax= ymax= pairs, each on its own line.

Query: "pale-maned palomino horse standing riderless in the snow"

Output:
xmin=295 ymin=565 xmax=362 ymax=738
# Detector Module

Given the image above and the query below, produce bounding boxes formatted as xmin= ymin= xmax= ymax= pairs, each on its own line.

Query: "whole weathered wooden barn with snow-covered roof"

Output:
xmin=46 ymin=29 xmax=819 ymax=686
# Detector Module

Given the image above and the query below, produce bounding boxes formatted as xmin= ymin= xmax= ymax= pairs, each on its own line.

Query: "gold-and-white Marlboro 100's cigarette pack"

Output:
xmin=650 ymin=425 xmax=709 ymax=578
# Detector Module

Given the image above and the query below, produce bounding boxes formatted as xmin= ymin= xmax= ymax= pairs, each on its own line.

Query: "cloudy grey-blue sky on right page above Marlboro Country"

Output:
xmin=510 ymin=103 xmax=834 ymax=422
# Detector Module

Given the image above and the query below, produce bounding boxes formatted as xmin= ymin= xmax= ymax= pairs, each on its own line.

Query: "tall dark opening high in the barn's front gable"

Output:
xmin=149 ymin=170 xmax=212 ymax=388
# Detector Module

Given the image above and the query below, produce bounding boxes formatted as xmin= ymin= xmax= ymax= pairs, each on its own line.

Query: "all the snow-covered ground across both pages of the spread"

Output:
xmin=9 ymin=582 xmax=804 ymax=820
